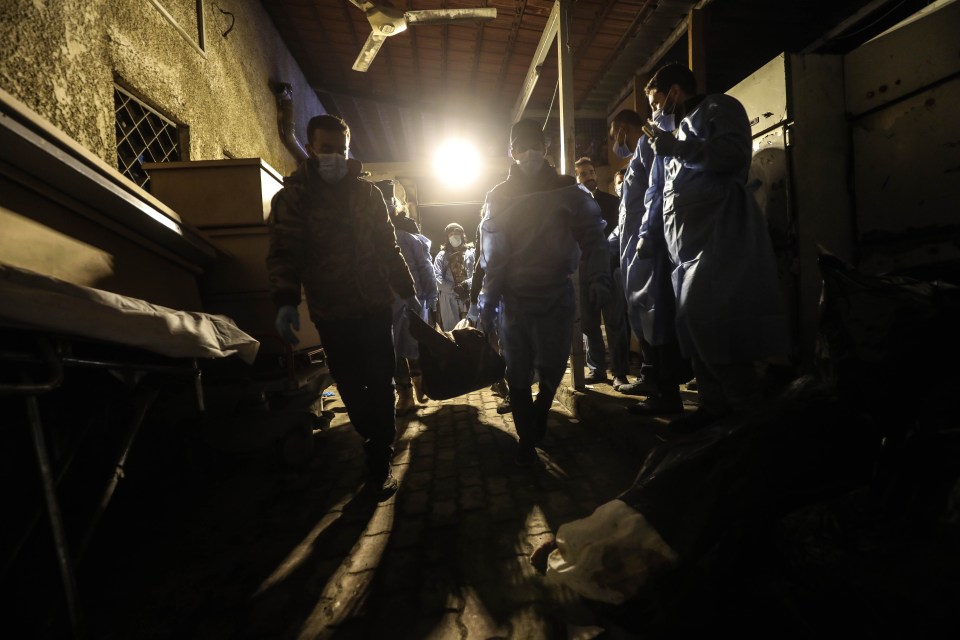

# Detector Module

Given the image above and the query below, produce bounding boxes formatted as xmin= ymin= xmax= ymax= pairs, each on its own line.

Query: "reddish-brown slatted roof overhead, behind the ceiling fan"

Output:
xmin=263 ymin=0 xmax=927 ymax=162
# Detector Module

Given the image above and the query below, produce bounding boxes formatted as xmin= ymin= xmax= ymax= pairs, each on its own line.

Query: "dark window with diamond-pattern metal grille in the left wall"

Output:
xmin=113 ymin=87 xmax=180 ymax=191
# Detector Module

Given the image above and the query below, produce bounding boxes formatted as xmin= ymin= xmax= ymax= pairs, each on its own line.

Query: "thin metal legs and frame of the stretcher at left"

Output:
xmin=0 ymin=333 xmax=205 ymax=636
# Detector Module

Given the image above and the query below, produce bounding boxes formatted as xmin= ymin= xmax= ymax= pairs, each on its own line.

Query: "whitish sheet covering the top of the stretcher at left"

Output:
xmin=0 ymin=264 xmax=260 ymax=363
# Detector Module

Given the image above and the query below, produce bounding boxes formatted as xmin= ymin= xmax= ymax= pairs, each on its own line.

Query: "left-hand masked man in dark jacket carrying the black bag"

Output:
xmin=267 ymin=115 xmax=418 ymax=493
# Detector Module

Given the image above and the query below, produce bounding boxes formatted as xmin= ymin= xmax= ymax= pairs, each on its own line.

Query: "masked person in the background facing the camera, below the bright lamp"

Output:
xmin=433 ymin=222 xmax=475 ymax=331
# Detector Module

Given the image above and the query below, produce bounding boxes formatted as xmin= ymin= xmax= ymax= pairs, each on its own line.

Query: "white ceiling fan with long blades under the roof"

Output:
xmin=350 ymin=0 xmax=497 ymax=71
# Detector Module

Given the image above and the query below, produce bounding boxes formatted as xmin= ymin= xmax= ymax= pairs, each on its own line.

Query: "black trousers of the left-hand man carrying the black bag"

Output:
xmin=317 ymin=308 xmax=396 ymax=473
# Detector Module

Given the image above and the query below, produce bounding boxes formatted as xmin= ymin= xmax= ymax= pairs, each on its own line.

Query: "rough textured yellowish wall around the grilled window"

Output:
xmin=0 ymin=0 xmax=323 ymax=174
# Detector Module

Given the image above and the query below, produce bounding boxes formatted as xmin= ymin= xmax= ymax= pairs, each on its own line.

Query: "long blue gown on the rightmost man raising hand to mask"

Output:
xmin=663 ymin=95 xmax=789 ymax=364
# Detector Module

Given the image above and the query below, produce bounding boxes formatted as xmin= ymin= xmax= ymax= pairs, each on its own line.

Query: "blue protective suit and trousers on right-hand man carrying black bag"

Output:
xmin=480 ymin=165 xmax=611 ymax=446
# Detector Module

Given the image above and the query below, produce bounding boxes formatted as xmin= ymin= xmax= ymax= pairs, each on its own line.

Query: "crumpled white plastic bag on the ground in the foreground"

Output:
xmin=547 ymin=500 xmax=677 ymax=604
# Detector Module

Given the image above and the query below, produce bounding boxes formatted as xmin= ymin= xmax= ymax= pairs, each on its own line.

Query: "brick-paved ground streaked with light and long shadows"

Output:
xmin=80 ymin=376 xmax=692 ymax=639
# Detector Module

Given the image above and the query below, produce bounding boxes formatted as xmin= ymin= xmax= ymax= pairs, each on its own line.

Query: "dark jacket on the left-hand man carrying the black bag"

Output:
xmin=267 ymin=159 xmax=415 ymax=321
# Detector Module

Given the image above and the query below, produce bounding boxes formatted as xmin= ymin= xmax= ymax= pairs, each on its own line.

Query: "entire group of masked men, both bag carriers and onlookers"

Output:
xmin=267 ymin=65 xmax=789 ymax=494
